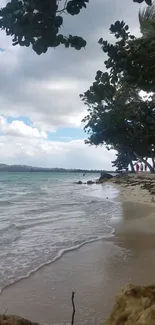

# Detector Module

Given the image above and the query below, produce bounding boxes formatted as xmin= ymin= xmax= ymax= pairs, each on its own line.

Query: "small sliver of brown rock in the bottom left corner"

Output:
xmin=0 ymin=315 xmax=39 ymax=325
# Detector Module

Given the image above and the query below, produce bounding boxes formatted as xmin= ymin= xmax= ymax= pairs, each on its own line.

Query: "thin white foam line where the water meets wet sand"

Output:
xmin=0 ymin=227 xmax=115 ymax=294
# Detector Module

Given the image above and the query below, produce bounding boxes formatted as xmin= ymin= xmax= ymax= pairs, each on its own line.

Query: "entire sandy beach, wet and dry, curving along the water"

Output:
xmin=0 ymin=175 xmax=155 ymax=325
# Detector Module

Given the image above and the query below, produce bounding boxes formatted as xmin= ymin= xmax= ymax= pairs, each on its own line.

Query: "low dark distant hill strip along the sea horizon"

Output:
xmin=0 ymin=164 xmax=114 ymax=173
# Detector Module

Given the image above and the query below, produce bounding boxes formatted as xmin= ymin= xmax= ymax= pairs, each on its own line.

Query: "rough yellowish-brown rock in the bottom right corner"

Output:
xmin=106 ymin=285 xmax=155 ymax=325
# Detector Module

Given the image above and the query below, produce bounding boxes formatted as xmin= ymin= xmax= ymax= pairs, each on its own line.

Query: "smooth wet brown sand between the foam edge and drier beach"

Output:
xmin=0 ymin=241 xmax=128 ymax=324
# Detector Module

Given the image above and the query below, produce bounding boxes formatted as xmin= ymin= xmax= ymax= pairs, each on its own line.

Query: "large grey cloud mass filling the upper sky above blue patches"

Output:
xmin=0 ymin=0 xmax=138 ymax=131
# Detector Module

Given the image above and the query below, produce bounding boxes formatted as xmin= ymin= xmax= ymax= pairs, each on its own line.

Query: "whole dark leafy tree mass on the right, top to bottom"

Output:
xmin=80 ymin=15 xmax=155 ymax=171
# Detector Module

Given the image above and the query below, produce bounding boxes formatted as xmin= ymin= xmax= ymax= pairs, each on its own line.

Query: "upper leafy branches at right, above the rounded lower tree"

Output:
xmin=99 ymin=4 xmax=155 ymax=92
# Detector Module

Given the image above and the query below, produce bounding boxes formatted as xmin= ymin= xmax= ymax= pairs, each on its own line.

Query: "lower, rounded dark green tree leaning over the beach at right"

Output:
xmin=80 ymin=65 xmax=155 ymax=171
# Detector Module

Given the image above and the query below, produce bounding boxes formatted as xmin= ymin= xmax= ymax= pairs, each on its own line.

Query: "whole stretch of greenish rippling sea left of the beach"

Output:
xmin=0 ymin=172 xmax=121 ymax=291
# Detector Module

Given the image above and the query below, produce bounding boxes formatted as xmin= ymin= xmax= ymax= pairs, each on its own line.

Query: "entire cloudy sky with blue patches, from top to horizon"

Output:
xmin=0 ymin=0 xmax=142 ymax=169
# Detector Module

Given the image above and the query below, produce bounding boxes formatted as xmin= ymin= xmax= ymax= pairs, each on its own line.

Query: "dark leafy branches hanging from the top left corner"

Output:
xmin=0 ymin=0 xmax=89 ymax=54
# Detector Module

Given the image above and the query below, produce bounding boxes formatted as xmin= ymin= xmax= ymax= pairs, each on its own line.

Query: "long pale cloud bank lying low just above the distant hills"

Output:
xmin=0 ymin=135 xmax=115 ymax=169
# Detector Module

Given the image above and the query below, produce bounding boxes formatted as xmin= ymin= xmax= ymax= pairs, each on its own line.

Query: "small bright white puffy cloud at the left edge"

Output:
xmin=0 ymin=116 xmax=47 ymax=139
